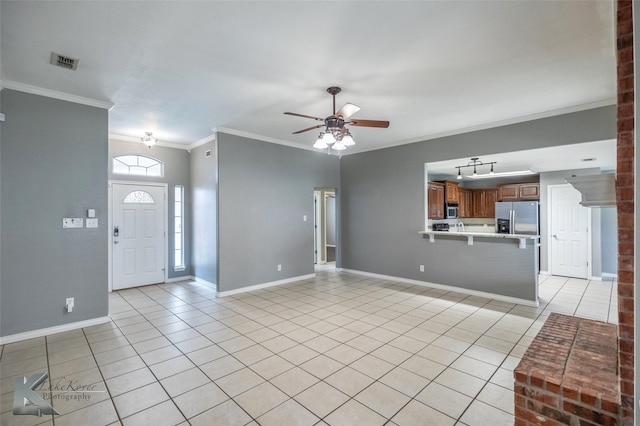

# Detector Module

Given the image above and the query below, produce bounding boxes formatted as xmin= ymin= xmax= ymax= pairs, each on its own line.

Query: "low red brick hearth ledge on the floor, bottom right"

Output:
xmin=514 ymin=313 xmax=620 ymax=426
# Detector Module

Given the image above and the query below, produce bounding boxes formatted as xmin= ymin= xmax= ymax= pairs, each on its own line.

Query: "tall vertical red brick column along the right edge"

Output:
xmin=616 ymin=0 xmax=635 ymax=424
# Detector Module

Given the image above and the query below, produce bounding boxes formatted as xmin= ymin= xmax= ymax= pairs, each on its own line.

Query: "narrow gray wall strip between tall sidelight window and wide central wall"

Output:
xmin=190 ymin=142 xmax=218 ymax=284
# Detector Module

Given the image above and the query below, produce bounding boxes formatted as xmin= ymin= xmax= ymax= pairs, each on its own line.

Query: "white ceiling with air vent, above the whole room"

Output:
xmin=0 ymin=0 xmax=616 ymax=156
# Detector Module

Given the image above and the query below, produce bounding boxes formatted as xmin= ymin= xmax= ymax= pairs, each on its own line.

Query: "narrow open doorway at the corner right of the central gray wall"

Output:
xmin=313 ymin=188 xmax=337 ymax=267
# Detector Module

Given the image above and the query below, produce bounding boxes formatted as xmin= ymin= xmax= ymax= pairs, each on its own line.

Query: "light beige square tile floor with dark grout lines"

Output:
xmin=0 ymin=271 xmax=617 ymax=426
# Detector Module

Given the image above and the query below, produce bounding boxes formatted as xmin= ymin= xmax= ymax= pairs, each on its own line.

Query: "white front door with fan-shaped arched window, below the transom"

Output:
xmin=111 ymin=183 xmax=166 ymax=290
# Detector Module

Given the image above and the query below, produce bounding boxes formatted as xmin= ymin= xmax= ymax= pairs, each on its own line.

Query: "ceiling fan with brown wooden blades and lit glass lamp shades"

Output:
xmin=285 ymin=86 xmax=389 ymax=151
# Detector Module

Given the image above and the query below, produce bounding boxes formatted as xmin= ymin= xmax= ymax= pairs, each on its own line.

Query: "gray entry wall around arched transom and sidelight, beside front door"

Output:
xmin=109 ymin=139 xmax=192 ymax=278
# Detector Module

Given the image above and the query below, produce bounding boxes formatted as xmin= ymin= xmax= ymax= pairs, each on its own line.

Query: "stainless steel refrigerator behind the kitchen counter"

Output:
xmin=496 ymin=201 xmax=540 ymax=235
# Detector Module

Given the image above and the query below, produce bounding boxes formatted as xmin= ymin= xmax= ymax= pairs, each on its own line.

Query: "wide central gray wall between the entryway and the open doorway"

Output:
xmin=217 ymin=133 xmax=340 ymax=291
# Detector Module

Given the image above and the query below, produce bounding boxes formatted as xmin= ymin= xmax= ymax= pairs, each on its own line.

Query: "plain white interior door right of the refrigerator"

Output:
xmin=549 ymin=185 xmax=589 ymax=278
